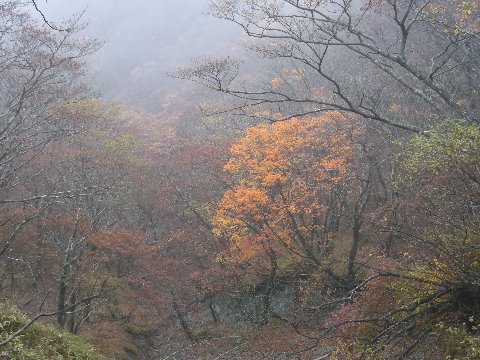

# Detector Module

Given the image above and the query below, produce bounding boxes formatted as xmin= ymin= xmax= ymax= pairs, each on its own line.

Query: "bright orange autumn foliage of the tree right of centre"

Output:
xmin=213 ymin=112 xmax=360 ymax=262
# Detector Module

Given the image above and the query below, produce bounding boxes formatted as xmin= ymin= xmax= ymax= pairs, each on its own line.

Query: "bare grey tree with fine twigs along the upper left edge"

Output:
xmin=0 ymin=1 xmax=99 ymax=256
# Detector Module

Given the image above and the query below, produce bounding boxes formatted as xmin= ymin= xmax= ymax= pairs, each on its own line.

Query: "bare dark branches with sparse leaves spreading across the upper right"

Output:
xmin=178 ymin=0 xmax=479 ymax=132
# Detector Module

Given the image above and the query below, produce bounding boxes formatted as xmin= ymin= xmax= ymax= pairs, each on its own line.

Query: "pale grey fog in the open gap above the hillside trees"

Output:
xmin=38 ymin=0 xmax=240 ymax=111
